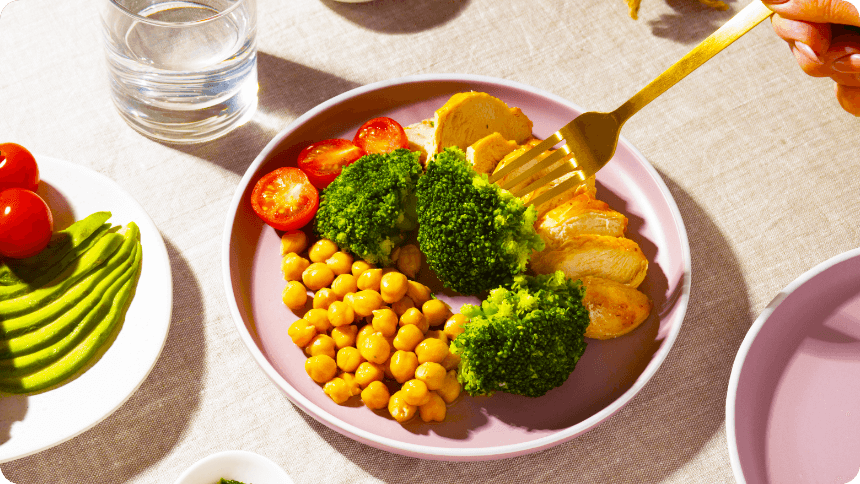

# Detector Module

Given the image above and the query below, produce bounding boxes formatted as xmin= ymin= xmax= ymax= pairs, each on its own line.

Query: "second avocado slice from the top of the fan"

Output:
xmin=0 ymin=233 xmax=124 ymax=322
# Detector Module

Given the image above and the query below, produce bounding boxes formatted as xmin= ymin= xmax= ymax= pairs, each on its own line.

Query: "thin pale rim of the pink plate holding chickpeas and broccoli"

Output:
xmin=221 ymin=73 xmax=692 ymax=460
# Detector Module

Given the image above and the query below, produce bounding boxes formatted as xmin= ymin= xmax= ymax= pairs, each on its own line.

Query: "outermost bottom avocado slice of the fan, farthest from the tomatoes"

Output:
xmin=0 ymin=223 xmax=142 ymax=393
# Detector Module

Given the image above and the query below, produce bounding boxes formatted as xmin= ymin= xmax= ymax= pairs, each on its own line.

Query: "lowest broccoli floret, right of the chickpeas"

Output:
xmin=451 ymin=271 xmax=589 ymax=397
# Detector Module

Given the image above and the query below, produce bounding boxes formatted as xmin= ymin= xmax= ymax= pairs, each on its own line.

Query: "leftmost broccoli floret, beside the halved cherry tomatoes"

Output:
xmin=314 ymin=149 xmax=423 ymax=265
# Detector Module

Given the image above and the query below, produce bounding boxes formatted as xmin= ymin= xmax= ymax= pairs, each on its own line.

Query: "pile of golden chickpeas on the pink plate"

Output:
xmin=281 ymin=231 xmax=466 ymax=423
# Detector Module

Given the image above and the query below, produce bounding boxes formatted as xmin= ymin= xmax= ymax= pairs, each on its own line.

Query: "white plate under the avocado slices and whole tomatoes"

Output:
xmin=0 ymin=156 xmax=173 ymax=462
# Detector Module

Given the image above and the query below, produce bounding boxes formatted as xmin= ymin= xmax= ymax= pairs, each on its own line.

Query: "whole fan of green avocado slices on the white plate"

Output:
xmin=0 ymin=212 xmax=142 ymax=393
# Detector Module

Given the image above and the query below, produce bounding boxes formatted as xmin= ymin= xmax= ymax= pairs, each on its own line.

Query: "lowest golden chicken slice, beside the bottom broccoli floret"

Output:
xmin=582 ymin=276 xmax=653 ymax=339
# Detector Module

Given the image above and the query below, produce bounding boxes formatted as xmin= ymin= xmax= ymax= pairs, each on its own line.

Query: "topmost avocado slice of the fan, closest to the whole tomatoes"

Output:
xmin=0 ymin=212 xmax=111 ymax=290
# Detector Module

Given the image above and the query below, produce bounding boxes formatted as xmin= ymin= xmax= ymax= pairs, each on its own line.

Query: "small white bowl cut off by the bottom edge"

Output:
xmin=174 ymin=450 xmax=293 ymax=484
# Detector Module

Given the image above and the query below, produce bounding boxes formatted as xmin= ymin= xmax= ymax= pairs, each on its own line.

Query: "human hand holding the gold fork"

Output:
xmin=761 ymin=0 xmax=860 ymax=116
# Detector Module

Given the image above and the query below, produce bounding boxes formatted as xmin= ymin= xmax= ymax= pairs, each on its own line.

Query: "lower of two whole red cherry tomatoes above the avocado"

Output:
xmin=0 ymin=188 xmax=54 ymax=259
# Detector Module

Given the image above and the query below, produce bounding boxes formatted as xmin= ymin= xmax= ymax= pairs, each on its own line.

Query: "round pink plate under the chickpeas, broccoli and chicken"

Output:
xmin=222 ymin=75 xmax=690 ymax=460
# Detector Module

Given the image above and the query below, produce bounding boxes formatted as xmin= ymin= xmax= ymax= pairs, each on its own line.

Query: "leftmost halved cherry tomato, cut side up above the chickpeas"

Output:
xmin=251 ymin=166 xmax=320 ymax=230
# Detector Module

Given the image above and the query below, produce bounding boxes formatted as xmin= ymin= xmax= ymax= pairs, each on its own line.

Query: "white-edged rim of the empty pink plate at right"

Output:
xmin=725 ymin=247 xmax=860 ymax=484
